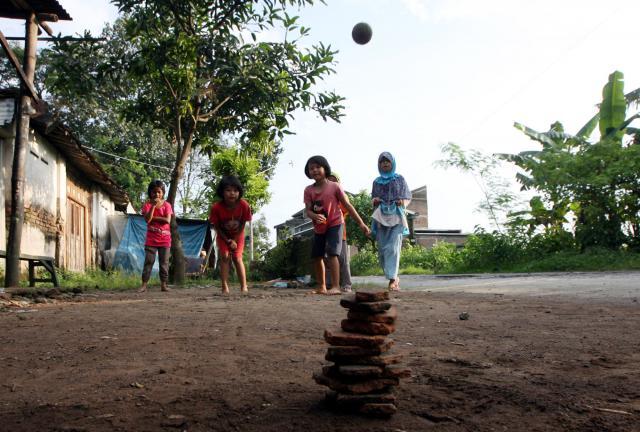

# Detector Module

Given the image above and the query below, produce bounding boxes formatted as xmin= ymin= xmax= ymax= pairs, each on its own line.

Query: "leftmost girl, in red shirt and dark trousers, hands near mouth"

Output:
xmin=138 ymin=180 xmax=173 ymax=292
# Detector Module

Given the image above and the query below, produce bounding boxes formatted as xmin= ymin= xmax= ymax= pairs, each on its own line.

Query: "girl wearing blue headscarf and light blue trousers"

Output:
xmin=371 ymin=152 xmax=411 ymax=291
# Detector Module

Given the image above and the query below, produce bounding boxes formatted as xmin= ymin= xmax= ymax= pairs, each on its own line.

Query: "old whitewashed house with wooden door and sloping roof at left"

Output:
xmin=0 ymin=89 xmax=133 ymax=271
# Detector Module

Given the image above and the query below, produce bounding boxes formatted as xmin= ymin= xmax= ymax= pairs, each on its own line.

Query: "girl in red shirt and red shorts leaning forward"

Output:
xmin=209 ymin=176 xmax=251 ymax=294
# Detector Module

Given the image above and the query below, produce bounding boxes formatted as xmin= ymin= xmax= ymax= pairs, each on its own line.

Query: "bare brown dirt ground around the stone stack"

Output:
xmin=0 ymin=288 xmax=640 ymax=432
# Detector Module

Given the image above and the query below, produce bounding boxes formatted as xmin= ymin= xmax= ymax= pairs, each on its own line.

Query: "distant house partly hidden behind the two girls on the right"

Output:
xmin=274 ymin=186 xmax=467 ymax=247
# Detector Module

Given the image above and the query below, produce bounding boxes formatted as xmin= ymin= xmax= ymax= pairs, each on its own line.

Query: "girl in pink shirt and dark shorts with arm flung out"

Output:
xmin=304 ymin=156 xmax=371 ymax=295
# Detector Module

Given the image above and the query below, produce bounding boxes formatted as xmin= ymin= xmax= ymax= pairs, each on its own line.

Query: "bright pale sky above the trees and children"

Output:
xmin=0 ymin=0 xmax=640 ymax=241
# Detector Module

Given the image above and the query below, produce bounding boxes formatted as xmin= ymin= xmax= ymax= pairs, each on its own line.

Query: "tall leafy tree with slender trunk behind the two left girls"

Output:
xmin=46 ymin=0 xmax=343 ymax=282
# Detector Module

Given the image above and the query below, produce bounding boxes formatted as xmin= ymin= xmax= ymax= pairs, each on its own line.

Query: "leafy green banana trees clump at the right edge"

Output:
xmin=501 ymin=71 xmax=640 ymax=250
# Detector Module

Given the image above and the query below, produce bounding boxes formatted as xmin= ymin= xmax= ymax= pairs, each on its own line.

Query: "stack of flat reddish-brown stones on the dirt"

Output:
xmin=313 ymin=291 xmax=411 ymax=417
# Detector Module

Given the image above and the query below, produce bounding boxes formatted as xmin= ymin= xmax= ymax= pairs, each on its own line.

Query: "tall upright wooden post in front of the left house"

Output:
xmin=4 ymin=12 xmax=38 ymax=287
